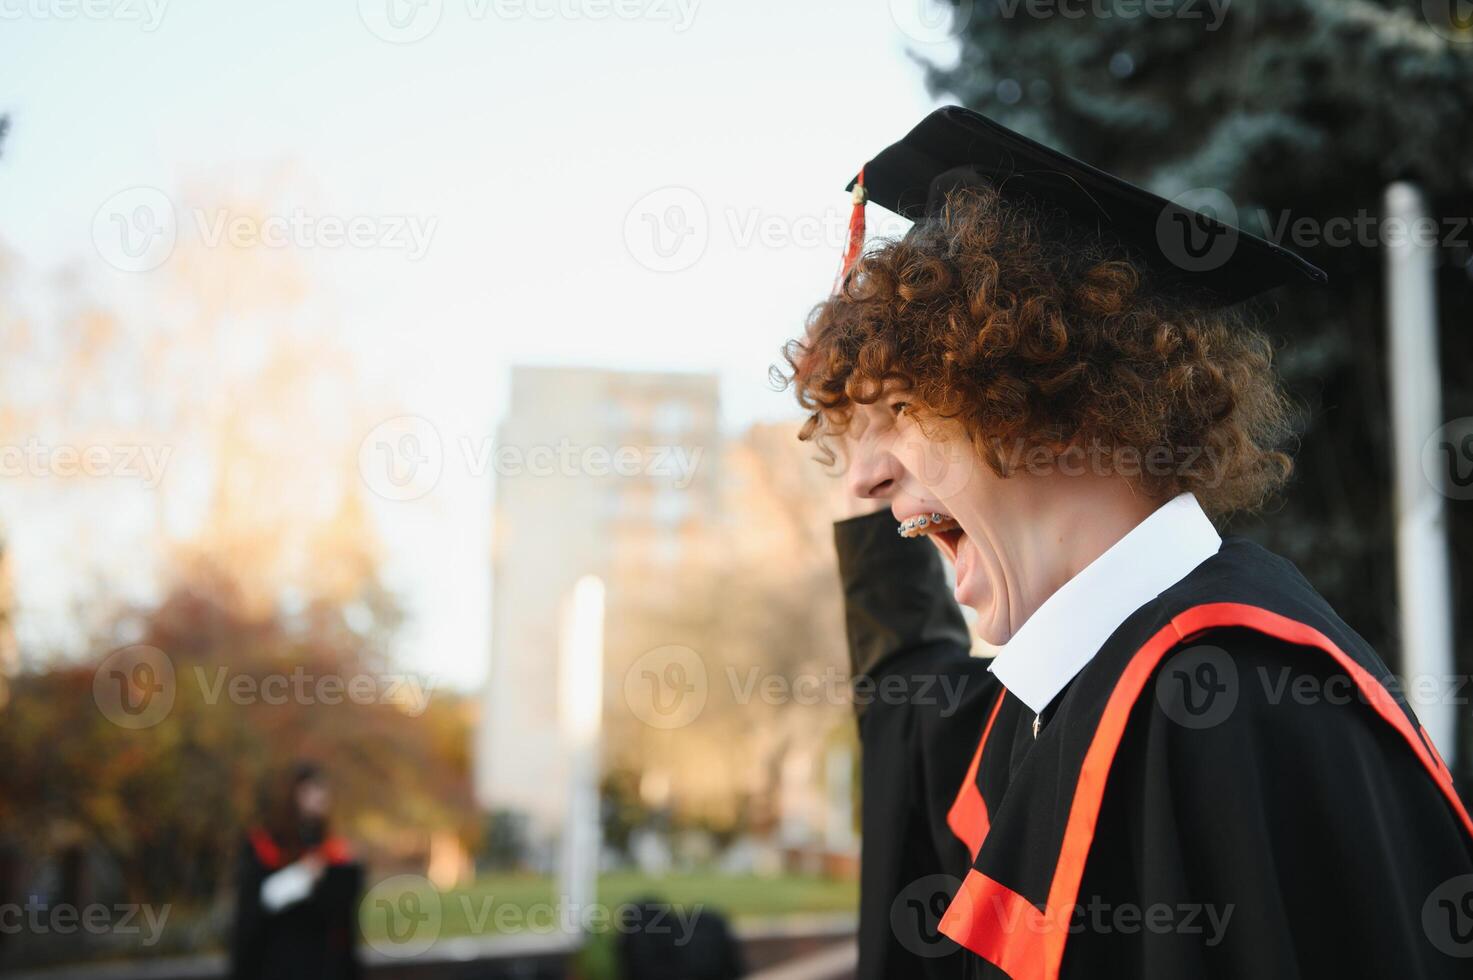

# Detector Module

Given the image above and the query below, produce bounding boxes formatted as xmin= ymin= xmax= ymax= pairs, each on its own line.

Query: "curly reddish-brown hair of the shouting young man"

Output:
xmin=784 ymin=186 xmax=1292 ymax=516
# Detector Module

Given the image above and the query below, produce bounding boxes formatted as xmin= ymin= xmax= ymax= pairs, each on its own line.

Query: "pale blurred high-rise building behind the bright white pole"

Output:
xmin=474 ymin=367 xmax=720 ymax=850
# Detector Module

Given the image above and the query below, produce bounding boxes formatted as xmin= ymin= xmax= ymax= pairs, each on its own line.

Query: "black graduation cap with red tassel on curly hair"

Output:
xmin=837 ymin=106 xmax=1329 ymax=307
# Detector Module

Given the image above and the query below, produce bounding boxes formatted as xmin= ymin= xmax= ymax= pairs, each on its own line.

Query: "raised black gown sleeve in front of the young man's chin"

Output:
xmin=834 ymin=511 xmax=999 ymax=980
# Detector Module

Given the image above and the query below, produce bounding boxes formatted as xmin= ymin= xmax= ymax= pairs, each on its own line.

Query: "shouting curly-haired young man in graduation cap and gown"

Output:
xmin=790 ymin=108 xmax=1473 ymax=979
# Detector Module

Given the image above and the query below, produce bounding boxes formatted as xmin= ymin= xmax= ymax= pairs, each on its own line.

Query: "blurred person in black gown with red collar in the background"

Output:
xmin=230 ymin=762 xmax=362 ymax=980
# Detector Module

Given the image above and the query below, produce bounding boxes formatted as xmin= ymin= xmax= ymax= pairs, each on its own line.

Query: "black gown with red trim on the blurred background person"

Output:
xmin=230 ymin=830 xmax=362 ymax=980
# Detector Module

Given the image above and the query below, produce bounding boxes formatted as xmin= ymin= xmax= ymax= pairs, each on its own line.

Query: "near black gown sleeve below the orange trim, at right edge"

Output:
xmin=1064 ymin=629 xmax=1473 ymax=980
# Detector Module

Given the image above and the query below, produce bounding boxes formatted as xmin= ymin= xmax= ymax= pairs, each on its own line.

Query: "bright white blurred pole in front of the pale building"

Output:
xmin=558 ymin=575 xmax=604 ymax=936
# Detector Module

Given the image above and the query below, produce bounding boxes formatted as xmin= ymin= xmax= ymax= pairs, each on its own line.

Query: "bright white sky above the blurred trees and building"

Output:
xmin=0 ymin=0 xmax=953 ymax=687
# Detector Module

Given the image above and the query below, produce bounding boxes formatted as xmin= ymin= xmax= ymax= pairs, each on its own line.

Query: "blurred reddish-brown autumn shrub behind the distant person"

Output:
xmin=0 ymin=573 xmax=476 ymax=903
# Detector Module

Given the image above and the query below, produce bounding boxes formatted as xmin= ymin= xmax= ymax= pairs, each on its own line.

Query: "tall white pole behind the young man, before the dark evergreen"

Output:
xmin=1385 ymin=183 xmax=1457 ymax=766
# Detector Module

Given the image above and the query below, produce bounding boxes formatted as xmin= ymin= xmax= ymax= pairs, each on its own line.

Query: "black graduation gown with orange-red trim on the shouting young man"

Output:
xmin=835 ymin=514 xmax=1473 ymax=979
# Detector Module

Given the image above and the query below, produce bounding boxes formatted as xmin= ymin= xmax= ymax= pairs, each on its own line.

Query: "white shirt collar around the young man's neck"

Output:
xmin=990 ymin=494 xmax=1223 ymax=713
